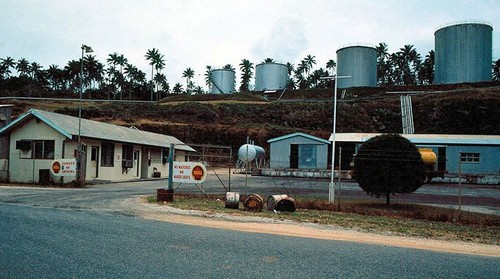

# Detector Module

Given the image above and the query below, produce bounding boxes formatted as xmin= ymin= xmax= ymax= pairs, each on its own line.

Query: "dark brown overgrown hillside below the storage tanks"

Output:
xmin=0 ymin=83 xmax=500 ymax=153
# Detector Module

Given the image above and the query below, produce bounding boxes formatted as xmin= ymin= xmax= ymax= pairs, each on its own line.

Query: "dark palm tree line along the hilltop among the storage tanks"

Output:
xmin=0 ymin=43 xmax=500 ymax=101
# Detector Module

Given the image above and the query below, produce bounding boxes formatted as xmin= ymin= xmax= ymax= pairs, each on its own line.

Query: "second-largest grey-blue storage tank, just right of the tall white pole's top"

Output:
xmin=337 ymin=44 xmax=377 ymax=88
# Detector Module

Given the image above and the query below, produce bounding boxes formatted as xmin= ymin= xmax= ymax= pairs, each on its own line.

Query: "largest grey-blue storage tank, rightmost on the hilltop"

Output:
xmin=434 ymin=22 xmax=493 ymax=84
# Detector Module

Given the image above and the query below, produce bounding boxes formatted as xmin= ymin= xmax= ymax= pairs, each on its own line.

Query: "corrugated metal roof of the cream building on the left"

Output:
xmin=0 ymin=109 xmax=196 ymax=151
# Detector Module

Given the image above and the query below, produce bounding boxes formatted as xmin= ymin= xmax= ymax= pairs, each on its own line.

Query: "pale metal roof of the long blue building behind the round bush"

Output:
xmin=330 ymin=133 xmax=500 ymax=145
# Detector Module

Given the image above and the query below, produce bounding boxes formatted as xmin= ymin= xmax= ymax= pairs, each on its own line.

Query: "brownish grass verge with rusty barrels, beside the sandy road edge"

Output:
xmin=147 ymin=194 xmax=500 ymax=245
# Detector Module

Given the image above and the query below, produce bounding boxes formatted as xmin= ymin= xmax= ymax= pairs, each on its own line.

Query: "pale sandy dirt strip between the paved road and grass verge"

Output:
xmin=135 ymin=200 xmax=500 ymax=257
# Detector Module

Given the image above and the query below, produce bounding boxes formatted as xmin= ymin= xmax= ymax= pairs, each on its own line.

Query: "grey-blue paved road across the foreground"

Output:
xmin=0 ymin=202 xmax=500 ymax=278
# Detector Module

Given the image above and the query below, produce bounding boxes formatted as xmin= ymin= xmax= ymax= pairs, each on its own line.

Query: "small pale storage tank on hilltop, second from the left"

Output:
xmin=254 ymin=63 xmax=288 ymax=91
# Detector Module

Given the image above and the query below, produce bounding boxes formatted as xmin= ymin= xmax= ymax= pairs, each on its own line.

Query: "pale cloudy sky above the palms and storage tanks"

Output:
xmin=0 ymin=0 xmax=500 ymax=87
